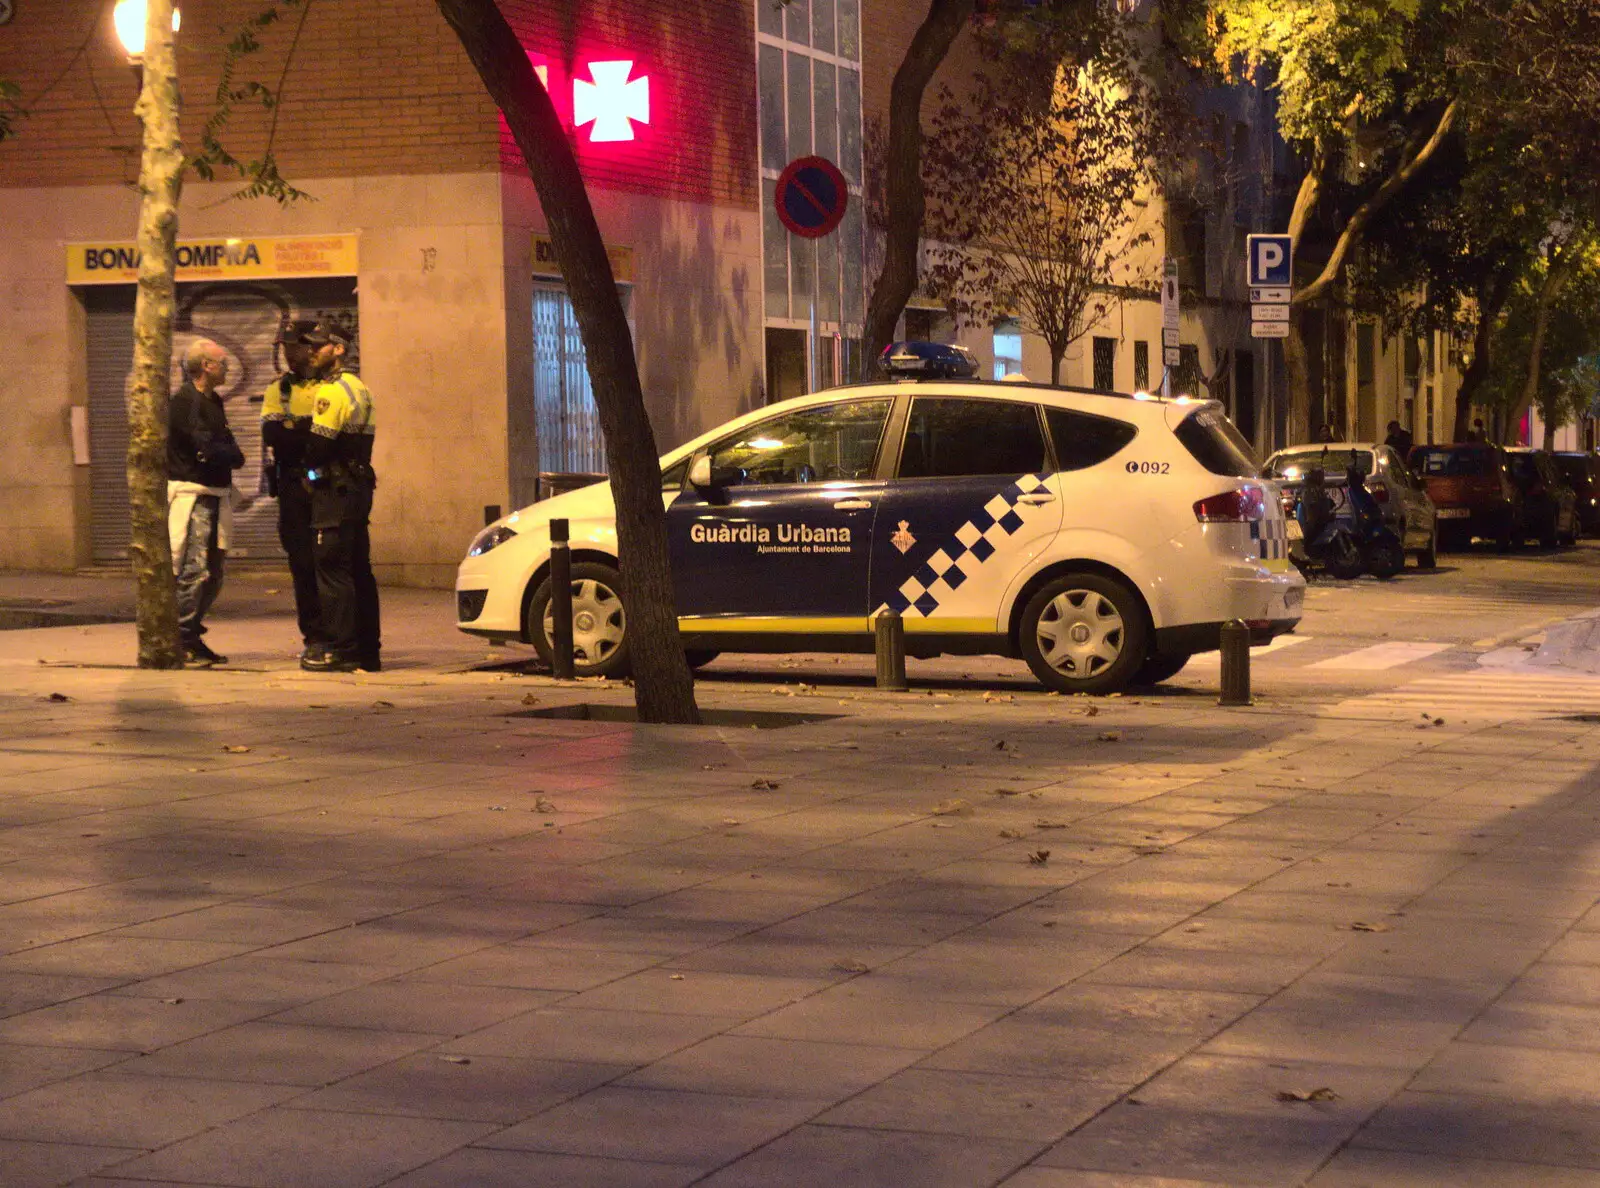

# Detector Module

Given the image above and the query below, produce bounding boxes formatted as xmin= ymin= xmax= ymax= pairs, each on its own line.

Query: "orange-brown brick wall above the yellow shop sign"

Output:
xmin=0 ymin=0 xmax=499 ymax=187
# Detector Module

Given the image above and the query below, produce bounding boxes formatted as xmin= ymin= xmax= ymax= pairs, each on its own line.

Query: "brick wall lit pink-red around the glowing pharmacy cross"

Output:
xmin=501 ymin=0 xmax=760 ymax=208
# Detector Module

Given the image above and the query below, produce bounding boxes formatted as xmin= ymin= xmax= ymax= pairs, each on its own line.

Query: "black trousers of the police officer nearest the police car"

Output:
xmin=312 ymin=484 xmax=382 ymax=666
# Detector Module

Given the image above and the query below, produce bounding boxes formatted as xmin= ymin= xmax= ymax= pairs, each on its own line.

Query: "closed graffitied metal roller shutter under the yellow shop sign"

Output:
xmin=83 ymin=277 xmax=360 ymax=562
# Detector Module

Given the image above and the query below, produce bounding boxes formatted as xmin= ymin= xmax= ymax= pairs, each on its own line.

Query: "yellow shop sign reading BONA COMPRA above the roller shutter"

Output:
xmin=67 ymin=235 xmax=358 ymax=285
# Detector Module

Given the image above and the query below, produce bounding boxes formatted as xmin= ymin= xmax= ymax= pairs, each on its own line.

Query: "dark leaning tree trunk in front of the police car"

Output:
xmin=438 ymin=0 xmax=699 ymax=722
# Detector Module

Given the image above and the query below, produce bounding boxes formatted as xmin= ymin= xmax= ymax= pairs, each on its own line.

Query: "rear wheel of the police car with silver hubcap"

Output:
xmin=1021 ymin=573 xmax=1149 ymax=693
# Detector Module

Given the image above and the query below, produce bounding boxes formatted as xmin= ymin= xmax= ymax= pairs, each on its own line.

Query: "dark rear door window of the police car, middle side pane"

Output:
xmin=899 ymin=395 xmax=1045 ymax=479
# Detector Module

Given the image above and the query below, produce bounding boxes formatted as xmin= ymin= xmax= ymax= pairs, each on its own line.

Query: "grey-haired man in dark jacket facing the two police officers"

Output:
xmin=166 ymin=338 xmax=245 ymax=664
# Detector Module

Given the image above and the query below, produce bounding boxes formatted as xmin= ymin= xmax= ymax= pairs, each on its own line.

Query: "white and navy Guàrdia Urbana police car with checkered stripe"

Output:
xmin=456 ymin=343 xmax=1306 ymax=693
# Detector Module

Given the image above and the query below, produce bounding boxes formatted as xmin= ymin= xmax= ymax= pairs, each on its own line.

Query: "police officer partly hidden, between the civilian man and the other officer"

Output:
xmin=261 ymin=319 xmax=326 ymax=660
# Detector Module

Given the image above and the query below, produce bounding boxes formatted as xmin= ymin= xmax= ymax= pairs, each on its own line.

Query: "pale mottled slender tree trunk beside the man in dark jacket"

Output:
xmin=128 ymin=0 xmax=184 ymax=668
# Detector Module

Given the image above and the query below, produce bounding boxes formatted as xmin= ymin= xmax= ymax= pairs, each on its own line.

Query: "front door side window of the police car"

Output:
xmin=710 ymin=400 xmax=891 ymax=485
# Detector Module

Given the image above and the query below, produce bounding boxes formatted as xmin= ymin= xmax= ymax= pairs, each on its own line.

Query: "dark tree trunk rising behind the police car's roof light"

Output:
xmin=861 ymin=0 xmax=974 ymax=379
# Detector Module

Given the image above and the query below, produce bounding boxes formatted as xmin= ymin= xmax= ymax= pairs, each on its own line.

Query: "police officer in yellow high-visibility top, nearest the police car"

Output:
xmin=301 ymin=322 xmax=381 ymax=672
